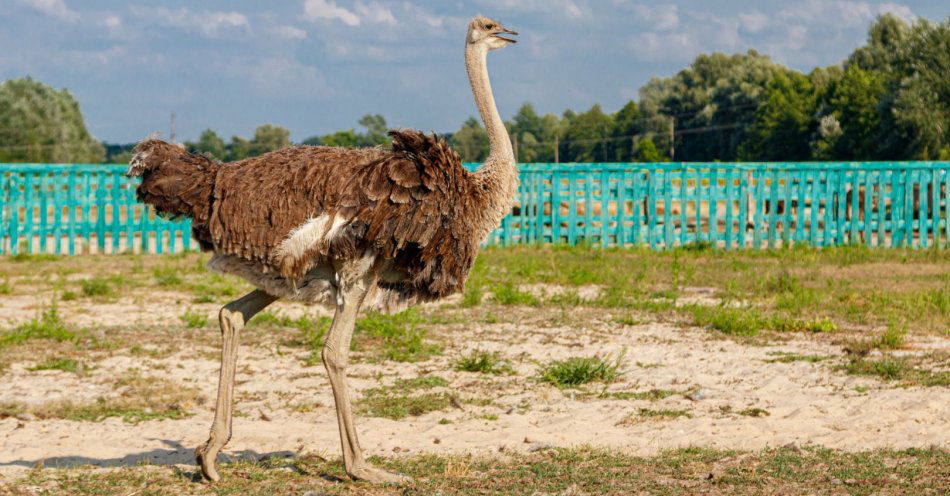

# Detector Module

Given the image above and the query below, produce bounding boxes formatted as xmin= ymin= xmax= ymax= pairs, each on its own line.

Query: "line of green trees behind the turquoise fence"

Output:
xmin=0 ymin=15 xmax=950 ymax=163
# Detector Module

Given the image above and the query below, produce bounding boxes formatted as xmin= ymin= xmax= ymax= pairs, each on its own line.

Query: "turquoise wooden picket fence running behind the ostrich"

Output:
xmin=0 ymin=162 xmax=950 ymax=254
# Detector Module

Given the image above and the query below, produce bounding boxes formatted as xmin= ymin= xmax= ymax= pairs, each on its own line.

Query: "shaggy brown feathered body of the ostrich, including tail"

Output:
xmin=130 ymin=131 xmax=498 ymax=300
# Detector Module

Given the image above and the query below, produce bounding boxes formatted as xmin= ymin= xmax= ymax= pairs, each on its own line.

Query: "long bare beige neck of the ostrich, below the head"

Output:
xmin=465 ymin=43 xmax=515 ymax=167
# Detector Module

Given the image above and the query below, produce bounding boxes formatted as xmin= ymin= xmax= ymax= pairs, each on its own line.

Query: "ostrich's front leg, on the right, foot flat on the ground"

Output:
xmin=323 ymin=258 xmax=409 ymax=483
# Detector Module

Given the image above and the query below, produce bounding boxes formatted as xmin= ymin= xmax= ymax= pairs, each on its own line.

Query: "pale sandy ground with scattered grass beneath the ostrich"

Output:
xmin=0 ymin=288 xmax=950 ymax=480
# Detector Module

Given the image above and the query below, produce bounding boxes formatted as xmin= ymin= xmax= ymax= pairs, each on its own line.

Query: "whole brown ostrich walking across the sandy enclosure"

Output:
xmin=128 ymin=16 xmax=518 ymax=482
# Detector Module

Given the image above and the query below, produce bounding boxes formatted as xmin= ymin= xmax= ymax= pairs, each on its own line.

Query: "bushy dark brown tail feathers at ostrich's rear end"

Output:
xmin=126 ymin=139 xmax=220 ymax=245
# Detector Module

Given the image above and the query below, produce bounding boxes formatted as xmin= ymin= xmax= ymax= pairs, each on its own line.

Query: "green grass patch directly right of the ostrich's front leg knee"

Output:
xmin=351 ymin=308 xmax=442 ymax=362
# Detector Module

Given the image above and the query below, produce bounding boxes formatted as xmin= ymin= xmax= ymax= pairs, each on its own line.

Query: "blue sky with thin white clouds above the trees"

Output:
xmin=0 ymin=0 xmax=950 ymax=142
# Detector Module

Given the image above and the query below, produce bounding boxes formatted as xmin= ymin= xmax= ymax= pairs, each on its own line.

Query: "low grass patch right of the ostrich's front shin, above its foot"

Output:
xmin=357 ymin=375 xmax=454 ymax=420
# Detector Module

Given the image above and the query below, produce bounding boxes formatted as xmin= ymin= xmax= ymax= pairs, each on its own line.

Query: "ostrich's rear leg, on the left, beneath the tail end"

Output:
xmin=195 ymin=289 xmax=277 ymax=481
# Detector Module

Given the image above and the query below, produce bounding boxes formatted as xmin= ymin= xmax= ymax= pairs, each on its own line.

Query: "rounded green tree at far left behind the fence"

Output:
xmin=0 ymin=78 xmax=104 ymax=163
